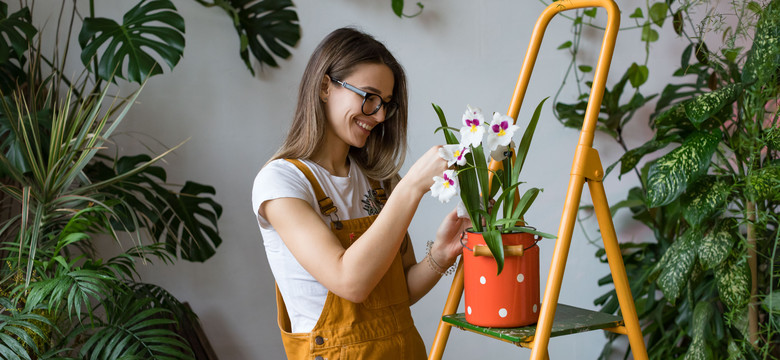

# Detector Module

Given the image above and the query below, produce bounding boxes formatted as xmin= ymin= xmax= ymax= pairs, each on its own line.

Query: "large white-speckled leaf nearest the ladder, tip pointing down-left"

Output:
xmin=647 ymin=131 xmax=721 ymax=208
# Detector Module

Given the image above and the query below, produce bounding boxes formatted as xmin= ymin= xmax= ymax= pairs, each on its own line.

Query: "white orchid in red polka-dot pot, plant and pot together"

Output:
xmin=431 ymin=99 xmax=555 ymax=327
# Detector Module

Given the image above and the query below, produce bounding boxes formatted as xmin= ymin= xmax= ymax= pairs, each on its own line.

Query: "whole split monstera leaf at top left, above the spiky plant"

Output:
xmin=79 ymin=0 xmax=184 ymax=83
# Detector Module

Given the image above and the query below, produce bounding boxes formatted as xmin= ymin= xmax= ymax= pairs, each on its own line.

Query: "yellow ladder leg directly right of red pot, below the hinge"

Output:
xmin=531 ymin=173 xmax=585 ymax=360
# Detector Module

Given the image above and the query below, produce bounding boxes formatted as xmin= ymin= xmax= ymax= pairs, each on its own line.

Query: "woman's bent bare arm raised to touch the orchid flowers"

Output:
xmin=259 ymin=147 xmax=447 ymax=303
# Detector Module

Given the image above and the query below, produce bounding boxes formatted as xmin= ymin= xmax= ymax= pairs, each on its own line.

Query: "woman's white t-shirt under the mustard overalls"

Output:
xmin=252 ymin=160 xmax=379 ymax=333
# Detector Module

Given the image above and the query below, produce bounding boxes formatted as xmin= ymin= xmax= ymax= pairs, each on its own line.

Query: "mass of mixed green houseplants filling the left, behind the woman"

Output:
xmin=0 ymin=0 xmax=300 ymax=359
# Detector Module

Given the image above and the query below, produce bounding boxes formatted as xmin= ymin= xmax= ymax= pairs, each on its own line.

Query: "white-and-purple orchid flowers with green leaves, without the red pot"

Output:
xmin=431 ymin=99 xmax=555 ymax=274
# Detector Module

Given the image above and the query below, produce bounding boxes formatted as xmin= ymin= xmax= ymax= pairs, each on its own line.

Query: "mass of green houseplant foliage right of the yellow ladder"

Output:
xmin=555 ymin=0 xmax=780 ymax=359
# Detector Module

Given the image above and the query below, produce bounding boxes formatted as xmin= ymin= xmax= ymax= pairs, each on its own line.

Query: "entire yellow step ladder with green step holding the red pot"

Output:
xmin=428 ymin=0 xmax=647 ymax=360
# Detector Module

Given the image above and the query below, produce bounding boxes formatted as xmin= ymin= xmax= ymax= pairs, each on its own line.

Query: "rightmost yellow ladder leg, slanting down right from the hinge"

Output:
xmin=588 ymin=180 xmax=647 ymax=360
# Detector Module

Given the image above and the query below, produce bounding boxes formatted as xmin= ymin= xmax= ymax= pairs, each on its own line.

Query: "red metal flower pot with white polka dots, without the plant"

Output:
xmin=463 ymin=232 xmax=540 ymax=327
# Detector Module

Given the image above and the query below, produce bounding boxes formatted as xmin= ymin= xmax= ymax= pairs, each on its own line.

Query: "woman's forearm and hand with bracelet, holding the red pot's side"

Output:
xmin=403 ymin=210 xmax=471 ymax=304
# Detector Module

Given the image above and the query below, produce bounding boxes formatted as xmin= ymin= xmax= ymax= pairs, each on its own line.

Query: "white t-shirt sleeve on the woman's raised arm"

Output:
xmin=252 ymin=160 xmax=314 ymax=229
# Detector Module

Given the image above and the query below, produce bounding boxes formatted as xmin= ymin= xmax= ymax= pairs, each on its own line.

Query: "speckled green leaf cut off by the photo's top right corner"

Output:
xmin=742 ymin=0 xmax=780 ymax=89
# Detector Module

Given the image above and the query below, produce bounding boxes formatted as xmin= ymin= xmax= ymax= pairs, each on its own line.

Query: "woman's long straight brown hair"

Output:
xmin=271 ymin=28 xmax=408 ymax=180
